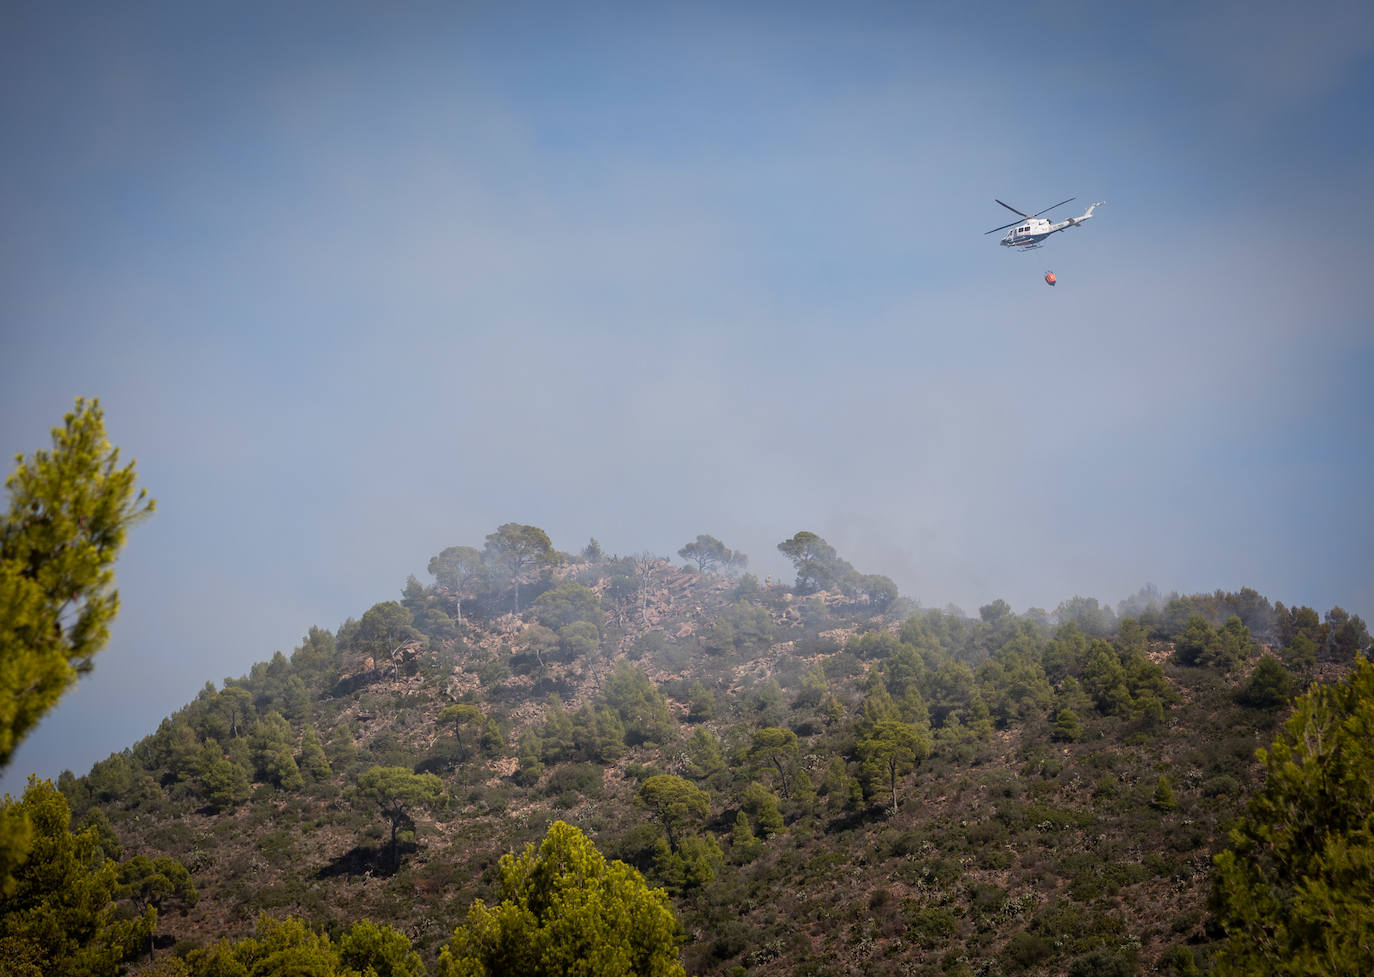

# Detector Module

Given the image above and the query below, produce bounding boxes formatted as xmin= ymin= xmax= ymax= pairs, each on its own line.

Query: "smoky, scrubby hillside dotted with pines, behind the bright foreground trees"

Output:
xmin=10 ymin=524 xmax=1370 ymax=974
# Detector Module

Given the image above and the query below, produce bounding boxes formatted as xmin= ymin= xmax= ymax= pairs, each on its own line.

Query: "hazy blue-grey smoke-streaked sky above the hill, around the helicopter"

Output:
xmin=0 ymin=0 xmax=1374 ymax=790
